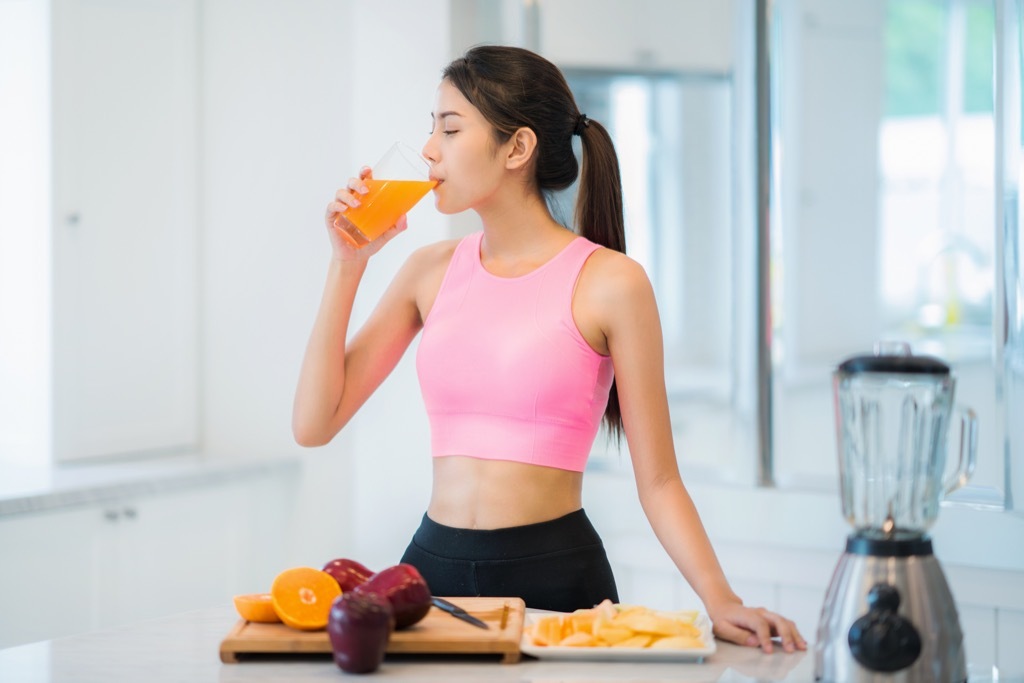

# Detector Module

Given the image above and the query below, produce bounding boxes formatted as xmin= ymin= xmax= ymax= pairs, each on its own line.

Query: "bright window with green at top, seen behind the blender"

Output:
xmin=879 ymin=0 xmax=995 ymax=352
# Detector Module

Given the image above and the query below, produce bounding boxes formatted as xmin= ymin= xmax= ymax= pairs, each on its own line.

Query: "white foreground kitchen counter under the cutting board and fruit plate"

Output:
xmin=0 ymin=607 xmax=814 ymax=683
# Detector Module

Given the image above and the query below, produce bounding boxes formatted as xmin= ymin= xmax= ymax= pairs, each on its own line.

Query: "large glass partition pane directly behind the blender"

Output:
xmin=771 ymin=0 xmax=1019 ymax=507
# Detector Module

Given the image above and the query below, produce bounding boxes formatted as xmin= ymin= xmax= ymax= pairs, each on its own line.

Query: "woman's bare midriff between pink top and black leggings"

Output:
xmin=427 ymin=456 xmax=583 ymax=529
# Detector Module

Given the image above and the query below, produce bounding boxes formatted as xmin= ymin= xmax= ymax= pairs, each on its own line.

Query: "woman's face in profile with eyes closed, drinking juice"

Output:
xmin=423 ymin=80 xmax=506 ymax=214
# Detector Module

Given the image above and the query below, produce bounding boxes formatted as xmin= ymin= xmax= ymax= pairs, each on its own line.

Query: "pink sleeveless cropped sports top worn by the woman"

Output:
xmin=416 ymin=232 xmax=612 ymax=472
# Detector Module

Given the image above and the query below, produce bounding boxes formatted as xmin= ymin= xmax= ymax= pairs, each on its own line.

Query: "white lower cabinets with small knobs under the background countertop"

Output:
xmin=0 ymin=477 xmax=290 ymax=648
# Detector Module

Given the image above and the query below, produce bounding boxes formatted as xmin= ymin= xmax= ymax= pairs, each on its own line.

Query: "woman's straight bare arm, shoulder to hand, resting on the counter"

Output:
xmin=581 ymin=251 xmax=807 ymax=652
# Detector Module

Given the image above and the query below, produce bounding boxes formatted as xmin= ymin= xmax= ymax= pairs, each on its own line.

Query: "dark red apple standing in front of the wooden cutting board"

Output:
xmin=327 ymin=591 xmax=394 ymax=674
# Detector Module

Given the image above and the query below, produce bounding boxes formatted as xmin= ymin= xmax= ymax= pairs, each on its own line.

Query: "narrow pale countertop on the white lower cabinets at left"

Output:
xmin=0 ymin=454 xmax=301 ymax=518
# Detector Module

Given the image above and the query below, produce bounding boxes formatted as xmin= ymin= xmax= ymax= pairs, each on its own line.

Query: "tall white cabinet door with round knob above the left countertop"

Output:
xmin=52 ymin=0 xmax=199 ymax=461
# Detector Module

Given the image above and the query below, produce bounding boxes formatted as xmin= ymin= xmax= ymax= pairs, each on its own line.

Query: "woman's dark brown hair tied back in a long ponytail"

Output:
xmin=443 ymin=45 xmax=626 ymax=437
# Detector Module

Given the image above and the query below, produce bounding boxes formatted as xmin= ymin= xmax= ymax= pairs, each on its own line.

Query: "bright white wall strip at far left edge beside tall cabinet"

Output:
xmin=0 ymin=0 xmax=52 ymax=464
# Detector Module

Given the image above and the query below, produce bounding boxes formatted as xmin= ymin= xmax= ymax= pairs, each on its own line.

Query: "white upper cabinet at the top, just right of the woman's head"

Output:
xmin=538 ymin=0 xmax=734 ymax=74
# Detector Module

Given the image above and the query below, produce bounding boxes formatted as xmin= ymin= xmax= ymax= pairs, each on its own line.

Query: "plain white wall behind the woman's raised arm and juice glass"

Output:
xmin=202 ymin=0 xmax=449 ymax=566
